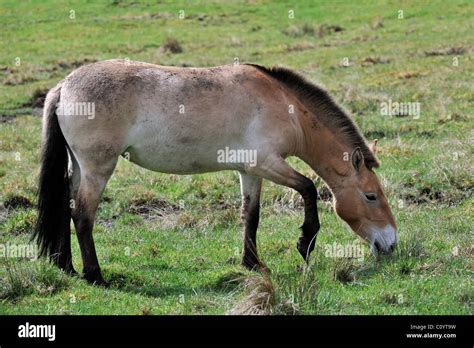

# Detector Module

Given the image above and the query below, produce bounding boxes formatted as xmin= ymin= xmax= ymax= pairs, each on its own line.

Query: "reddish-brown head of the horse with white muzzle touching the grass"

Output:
xmin=334 ymin=144 xmax=398 ymax=254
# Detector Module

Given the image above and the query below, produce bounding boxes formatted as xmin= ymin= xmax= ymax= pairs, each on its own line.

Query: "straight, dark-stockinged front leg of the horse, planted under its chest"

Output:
xmin=240 ymin=172 xmax=262 ymax=269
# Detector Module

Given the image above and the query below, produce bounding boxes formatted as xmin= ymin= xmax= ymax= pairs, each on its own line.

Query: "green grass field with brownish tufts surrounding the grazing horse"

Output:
xmin=0 ymin=0 xmax=474 ymax=314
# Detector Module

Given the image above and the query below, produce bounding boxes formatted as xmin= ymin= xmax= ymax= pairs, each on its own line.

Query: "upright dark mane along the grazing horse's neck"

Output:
xmin=248 ymin=64 xmax=379 ymax=169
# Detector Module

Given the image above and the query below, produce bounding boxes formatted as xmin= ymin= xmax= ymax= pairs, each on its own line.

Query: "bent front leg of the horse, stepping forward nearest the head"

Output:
xmin=248 ymin=155 xmax=320 ymax=261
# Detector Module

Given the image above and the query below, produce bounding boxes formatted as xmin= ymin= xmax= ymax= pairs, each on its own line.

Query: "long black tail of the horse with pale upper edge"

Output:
xmin=32 ymin=83 xmax=71 ymax=263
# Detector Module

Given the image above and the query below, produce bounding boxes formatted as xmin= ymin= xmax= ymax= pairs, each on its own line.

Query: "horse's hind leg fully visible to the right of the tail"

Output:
xmin=72 ymin=159 xmax=117 ymax=284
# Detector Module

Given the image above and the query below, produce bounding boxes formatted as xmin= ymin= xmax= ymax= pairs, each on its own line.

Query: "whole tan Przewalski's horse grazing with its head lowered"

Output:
xmin=34 ymin=60 xmax=397 ymax=283
